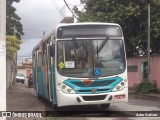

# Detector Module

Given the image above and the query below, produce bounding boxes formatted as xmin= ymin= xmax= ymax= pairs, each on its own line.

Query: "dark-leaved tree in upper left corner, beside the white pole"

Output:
xmin=6 ymin=0 xmax=24 ymax=39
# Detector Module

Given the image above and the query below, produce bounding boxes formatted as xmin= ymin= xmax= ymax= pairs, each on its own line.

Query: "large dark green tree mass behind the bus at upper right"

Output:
xmin=74 ymin=0 xmax=160 ymax=56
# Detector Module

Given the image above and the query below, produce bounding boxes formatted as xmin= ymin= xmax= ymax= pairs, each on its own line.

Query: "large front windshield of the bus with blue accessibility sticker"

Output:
xmin=57 ymin=38 xmax=125 ymax=78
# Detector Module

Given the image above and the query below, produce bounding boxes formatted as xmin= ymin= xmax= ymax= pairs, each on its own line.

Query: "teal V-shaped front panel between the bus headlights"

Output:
xmin=63 ymin=77 xmax=123 ymax=94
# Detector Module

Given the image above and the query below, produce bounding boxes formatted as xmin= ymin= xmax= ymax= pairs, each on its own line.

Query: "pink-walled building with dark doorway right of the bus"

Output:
xmin=127 ymin=55 xmax=160 ymax=90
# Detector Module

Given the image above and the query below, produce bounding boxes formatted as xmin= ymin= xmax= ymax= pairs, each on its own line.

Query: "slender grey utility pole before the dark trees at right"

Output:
xmin=147 ymin=4 xmax=151 ymax=80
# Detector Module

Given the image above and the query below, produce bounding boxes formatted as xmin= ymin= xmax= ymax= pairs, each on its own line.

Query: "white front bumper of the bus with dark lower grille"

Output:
xmin=57 ymin=88 xmax=128 ymax=107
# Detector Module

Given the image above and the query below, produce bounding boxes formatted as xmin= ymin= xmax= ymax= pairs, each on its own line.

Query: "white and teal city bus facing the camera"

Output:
xmin=32 ymin=23 xmax=128 ymax=109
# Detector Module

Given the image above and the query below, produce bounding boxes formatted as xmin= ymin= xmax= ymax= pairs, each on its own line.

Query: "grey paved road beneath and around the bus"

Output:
xmin=7 ymin=83 xmax=160 ymax=120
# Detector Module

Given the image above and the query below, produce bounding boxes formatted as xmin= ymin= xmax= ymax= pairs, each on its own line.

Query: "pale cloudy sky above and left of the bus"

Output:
xmin=13 ymin=0 xmax=80 ymax=61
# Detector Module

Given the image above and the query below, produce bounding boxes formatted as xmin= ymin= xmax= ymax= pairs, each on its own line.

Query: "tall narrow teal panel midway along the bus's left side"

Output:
xmin=37 ymin=67 xmax=44 ymax=96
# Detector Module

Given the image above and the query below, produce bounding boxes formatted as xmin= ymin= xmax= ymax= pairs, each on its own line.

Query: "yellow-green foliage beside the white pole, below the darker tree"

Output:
xmin=6 ymin=36 xmax=22 ymax=60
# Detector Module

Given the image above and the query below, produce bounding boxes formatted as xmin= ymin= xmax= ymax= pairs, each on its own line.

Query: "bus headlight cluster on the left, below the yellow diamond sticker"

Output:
xmin=57 ymin=83 xmax=75 ymax=94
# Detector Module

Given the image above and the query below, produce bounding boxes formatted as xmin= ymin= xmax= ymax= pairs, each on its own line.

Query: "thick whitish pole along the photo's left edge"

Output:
xmin=0 ymin=0 xmax=6 ymax=115
